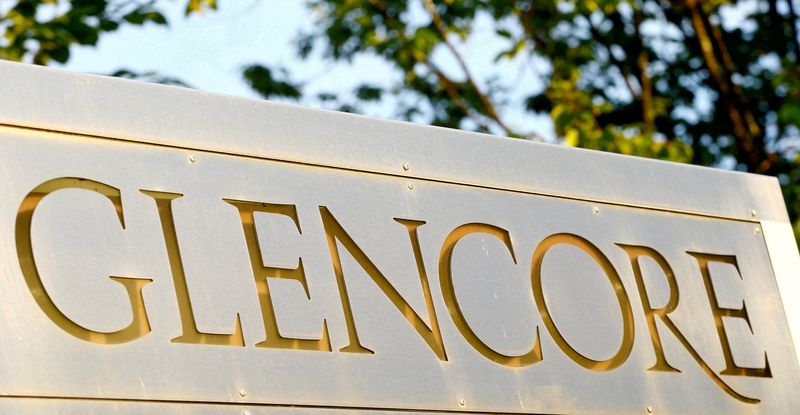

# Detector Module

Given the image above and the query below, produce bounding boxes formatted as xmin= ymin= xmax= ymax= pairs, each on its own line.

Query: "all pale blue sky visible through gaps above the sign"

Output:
xmin=56 ymin=0 xmax=555 ymax=139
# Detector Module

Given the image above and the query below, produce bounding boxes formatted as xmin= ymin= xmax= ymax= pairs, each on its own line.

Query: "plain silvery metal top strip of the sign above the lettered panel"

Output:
xmin=0 ymin=61 xmax=788 ymax=223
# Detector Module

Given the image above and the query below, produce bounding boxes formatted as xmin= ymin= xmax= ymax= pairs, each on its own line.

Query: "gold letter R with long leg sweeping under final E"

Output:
xmin=617 ymin=244 xmax=761 ymax=403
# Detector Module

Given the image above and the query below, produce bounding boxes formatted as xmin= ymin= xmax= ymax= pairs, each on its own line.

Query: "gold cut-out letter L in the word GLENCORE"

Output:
xmin=140 ymin=190 xmax=244 ymax=346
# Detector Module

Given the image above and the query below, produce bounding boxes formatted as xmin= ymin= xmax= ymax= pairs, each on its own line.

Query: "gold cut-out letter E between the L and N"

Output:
xmin=223 ymin=199 xmax=332 ymax=352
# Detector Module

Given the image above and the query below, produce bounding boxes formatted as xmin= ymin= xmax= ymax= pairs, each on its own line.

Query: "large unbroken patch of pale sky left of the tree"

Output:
xmin=58 ymin=0 xmax=362 ymax=97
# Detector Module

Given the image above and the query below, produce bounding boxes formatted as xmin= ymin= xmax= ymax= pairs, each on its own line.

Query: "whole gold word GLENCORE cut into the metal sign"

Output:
xmin=15 ymin=177 xmax=772 ymax=403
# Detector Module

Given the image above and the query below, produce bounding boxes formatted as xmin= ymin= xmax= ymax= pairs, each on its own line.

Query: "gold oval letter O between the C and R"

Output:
xmin=531 ymin=233 xmax=634 ymax=372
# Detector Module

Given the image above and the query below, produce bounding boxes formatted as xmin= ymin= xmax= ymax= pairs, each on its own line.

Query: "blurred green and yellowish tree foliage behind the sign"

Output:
xmin=0 ymin=0 xmax=800 ymax=239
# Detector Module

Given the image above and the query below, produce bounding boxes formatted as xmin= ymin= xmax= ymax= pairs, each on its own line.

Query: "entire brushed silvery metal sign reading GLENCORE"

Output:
xmin=0 ymin=60 xmax=800 ymax=414
